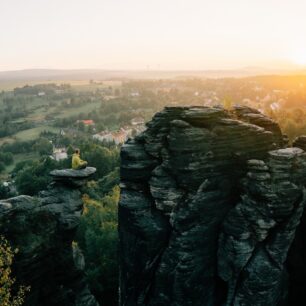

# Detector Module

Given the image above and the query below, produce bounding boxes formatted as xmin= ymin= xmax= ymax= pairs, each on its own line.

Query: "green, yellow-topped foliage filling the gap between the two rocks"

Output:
xmin=77 ymin=186 xmax=120 ymax=306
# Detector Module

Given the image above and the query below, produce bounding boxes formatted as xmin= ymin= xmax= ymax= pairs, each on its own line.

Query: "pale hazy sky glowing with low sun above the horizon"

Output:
xmin=0 ymin=0 xmax=306 ymax=70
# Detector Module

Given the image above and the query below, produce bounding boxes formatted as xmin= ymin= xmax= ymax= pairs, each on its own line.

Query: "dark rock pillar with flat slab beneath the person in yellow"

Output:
xmin=0 ymin=168 xmax=98 ymax=306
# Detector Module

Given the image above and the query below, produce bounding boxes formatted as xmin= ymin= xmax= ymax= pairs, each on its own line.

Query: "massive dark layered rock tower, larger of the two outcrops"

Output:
xmin=119 ymin=107 xmax=306 ymax=306
